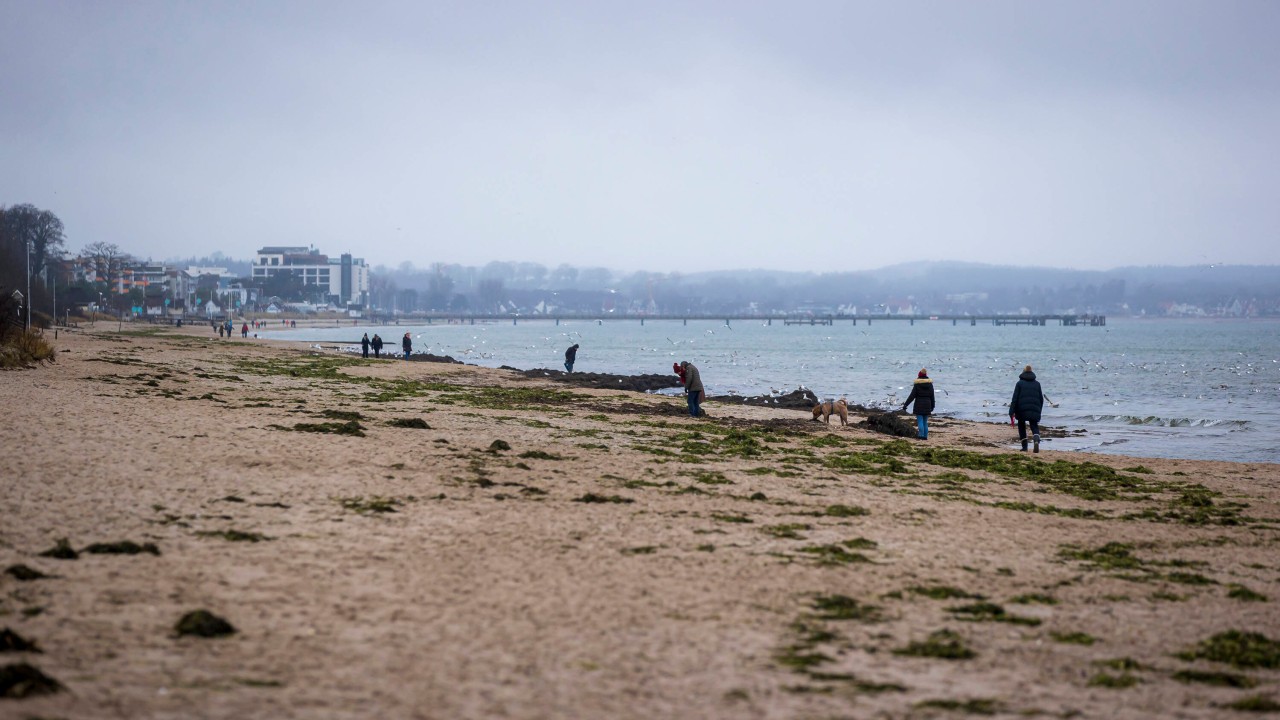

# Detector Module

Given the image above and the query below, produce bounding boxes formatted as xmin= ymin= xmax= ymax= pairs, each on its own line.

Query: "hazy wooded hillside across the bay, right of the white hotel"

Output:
xmin=371 ymin=257 xmax=1280 ymax=315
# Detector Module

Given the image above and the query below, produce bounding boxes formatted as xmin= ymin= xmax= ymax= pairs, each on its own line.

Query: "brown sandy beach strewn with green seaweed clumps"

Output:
xmin=0 ymin=324 xmax=1280 ymax=719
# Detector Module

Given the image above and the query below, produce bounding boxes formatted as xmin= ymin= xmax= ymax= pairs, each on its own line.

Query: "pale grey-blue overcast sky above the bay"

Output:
xmin=0 ymin=0 xmax=1280 ymax=272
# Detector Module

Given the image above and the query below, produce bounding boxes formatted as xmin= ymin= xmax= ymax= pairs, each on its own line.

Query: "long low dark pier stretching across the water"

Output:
xmin=401 ymin=313 xmax=1107 ymax=328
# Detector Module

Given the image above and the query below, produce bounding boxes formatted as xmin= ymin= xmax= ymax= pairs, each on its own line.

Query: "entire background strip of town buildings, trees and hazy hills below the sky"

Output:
xmin=0 ymin=205 xmax=1280 ymax=322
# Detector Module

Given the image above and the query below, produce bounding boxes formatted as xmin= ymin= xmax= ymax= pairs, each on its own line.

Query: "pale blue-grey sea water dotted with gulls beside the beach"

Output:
xmin=260 ymin=319 xmax=1280 ymax=462
